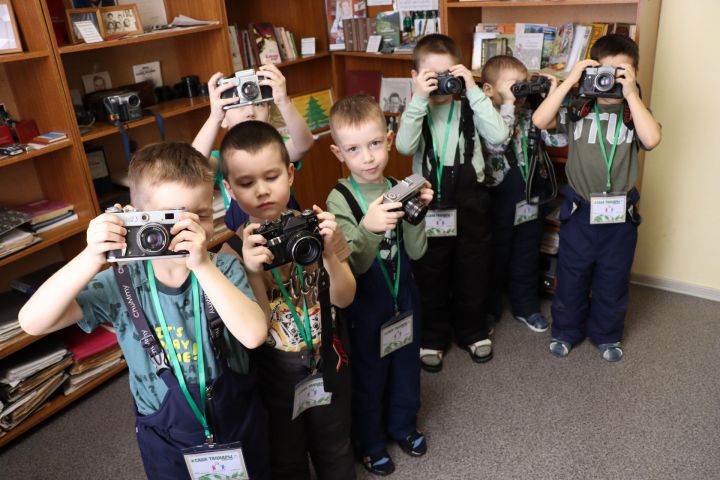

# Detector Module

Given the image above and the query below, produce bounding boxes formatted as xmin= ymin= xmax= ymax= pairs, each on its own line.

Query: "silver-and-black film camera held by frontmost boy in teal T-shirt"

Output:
xmin=105 ymin=207 xmax=188 ymax=262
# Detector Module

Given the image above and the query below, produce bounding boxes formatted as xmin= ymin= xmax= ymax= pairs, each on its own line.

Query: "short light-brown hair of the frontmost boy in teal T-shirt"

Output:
xmin=128 ymin=142 xmax=213 ymax=203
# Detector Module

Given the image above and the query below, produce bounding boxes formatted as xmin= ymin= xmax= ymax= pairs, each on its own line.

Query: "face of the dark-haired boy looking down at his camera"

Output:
xmin=223 ymin=145 xmax=295 ymax=221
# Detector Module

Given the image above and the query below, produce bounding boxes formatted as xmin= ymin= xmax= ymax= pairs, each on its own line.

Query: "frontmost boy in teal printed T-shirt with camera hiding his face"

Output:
xmin=19 ymin=143 xmax=269 ymax=479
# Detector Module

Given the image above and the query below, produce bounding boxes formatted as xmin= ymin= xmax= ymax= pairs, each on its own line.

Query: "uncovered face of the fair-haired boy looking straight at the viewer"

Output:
xmin=330 ymin=120 xmax=393 ymax=183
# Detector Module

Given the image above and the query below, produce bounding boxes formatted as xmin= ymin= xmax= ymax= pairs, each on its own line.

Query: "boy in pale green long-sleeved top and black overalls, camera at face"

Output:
xmin=397 ymin=34 xmax=509 ymax=372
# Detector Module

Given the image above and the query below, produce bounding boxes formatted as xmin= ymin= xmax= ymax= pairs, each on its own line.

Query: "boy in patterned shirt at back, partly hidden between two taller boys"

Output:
xmin=482 ymin=55 xmax=557 ymax=332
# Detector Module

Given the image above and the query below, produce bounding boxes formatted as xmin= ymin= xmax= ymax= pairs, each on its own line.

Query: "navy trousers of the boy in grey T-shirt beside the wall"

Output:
xmin=552 ymin=186 xmax=640 ymax=345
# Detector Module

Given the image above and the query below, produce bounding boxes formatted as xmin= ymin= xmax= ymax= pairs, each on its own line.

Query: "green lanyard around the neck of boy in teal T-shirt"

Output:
xmin=147 ymin=261 xmax=213 ymax=444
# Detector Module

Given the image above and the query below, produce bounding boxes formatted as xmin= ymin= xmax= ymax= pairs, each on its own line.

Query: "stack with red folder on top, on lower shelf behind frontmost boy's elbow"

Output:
xmin=63 ymin=325 xmax=125 ymax=395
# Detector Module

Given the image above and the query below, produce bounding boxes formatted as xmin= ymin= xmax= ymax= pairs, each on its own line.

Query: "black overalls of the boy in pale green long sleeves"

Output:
xmin=413 ymin=165 xmax=492 ymax=350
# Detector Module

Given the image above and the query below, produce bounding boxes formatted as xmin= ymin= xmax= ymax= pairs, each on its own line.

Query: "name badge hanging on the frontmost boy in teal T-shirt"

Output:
xmin=182 ymin=442 xmax=250 ymax=480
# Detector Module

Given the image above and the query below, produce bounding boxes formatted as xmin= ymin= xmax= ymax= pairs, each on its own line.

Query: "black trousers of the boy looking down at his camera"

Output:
xmin=257 ymin=346 xmax=355 ymax=480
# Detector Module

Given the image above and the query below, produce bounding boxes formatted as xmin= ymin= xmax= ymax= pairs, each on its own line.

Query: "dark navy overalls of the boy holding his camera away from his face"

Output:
xmin=342 ymin=249 xmax=421 ymax=455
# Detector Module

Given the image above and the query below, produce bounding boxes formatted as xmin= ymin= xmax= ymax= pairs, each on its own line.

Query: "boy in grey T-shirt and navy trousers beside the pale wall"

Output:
xmin=533 ymin=35 xmax=661 ymax=362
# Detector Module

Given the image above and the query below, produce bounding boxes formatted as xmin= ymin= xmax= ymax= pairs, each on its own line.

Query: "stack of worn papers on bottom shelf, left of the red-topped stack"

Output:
xmin=0 ymin=338 xmax=72 ymax=431
